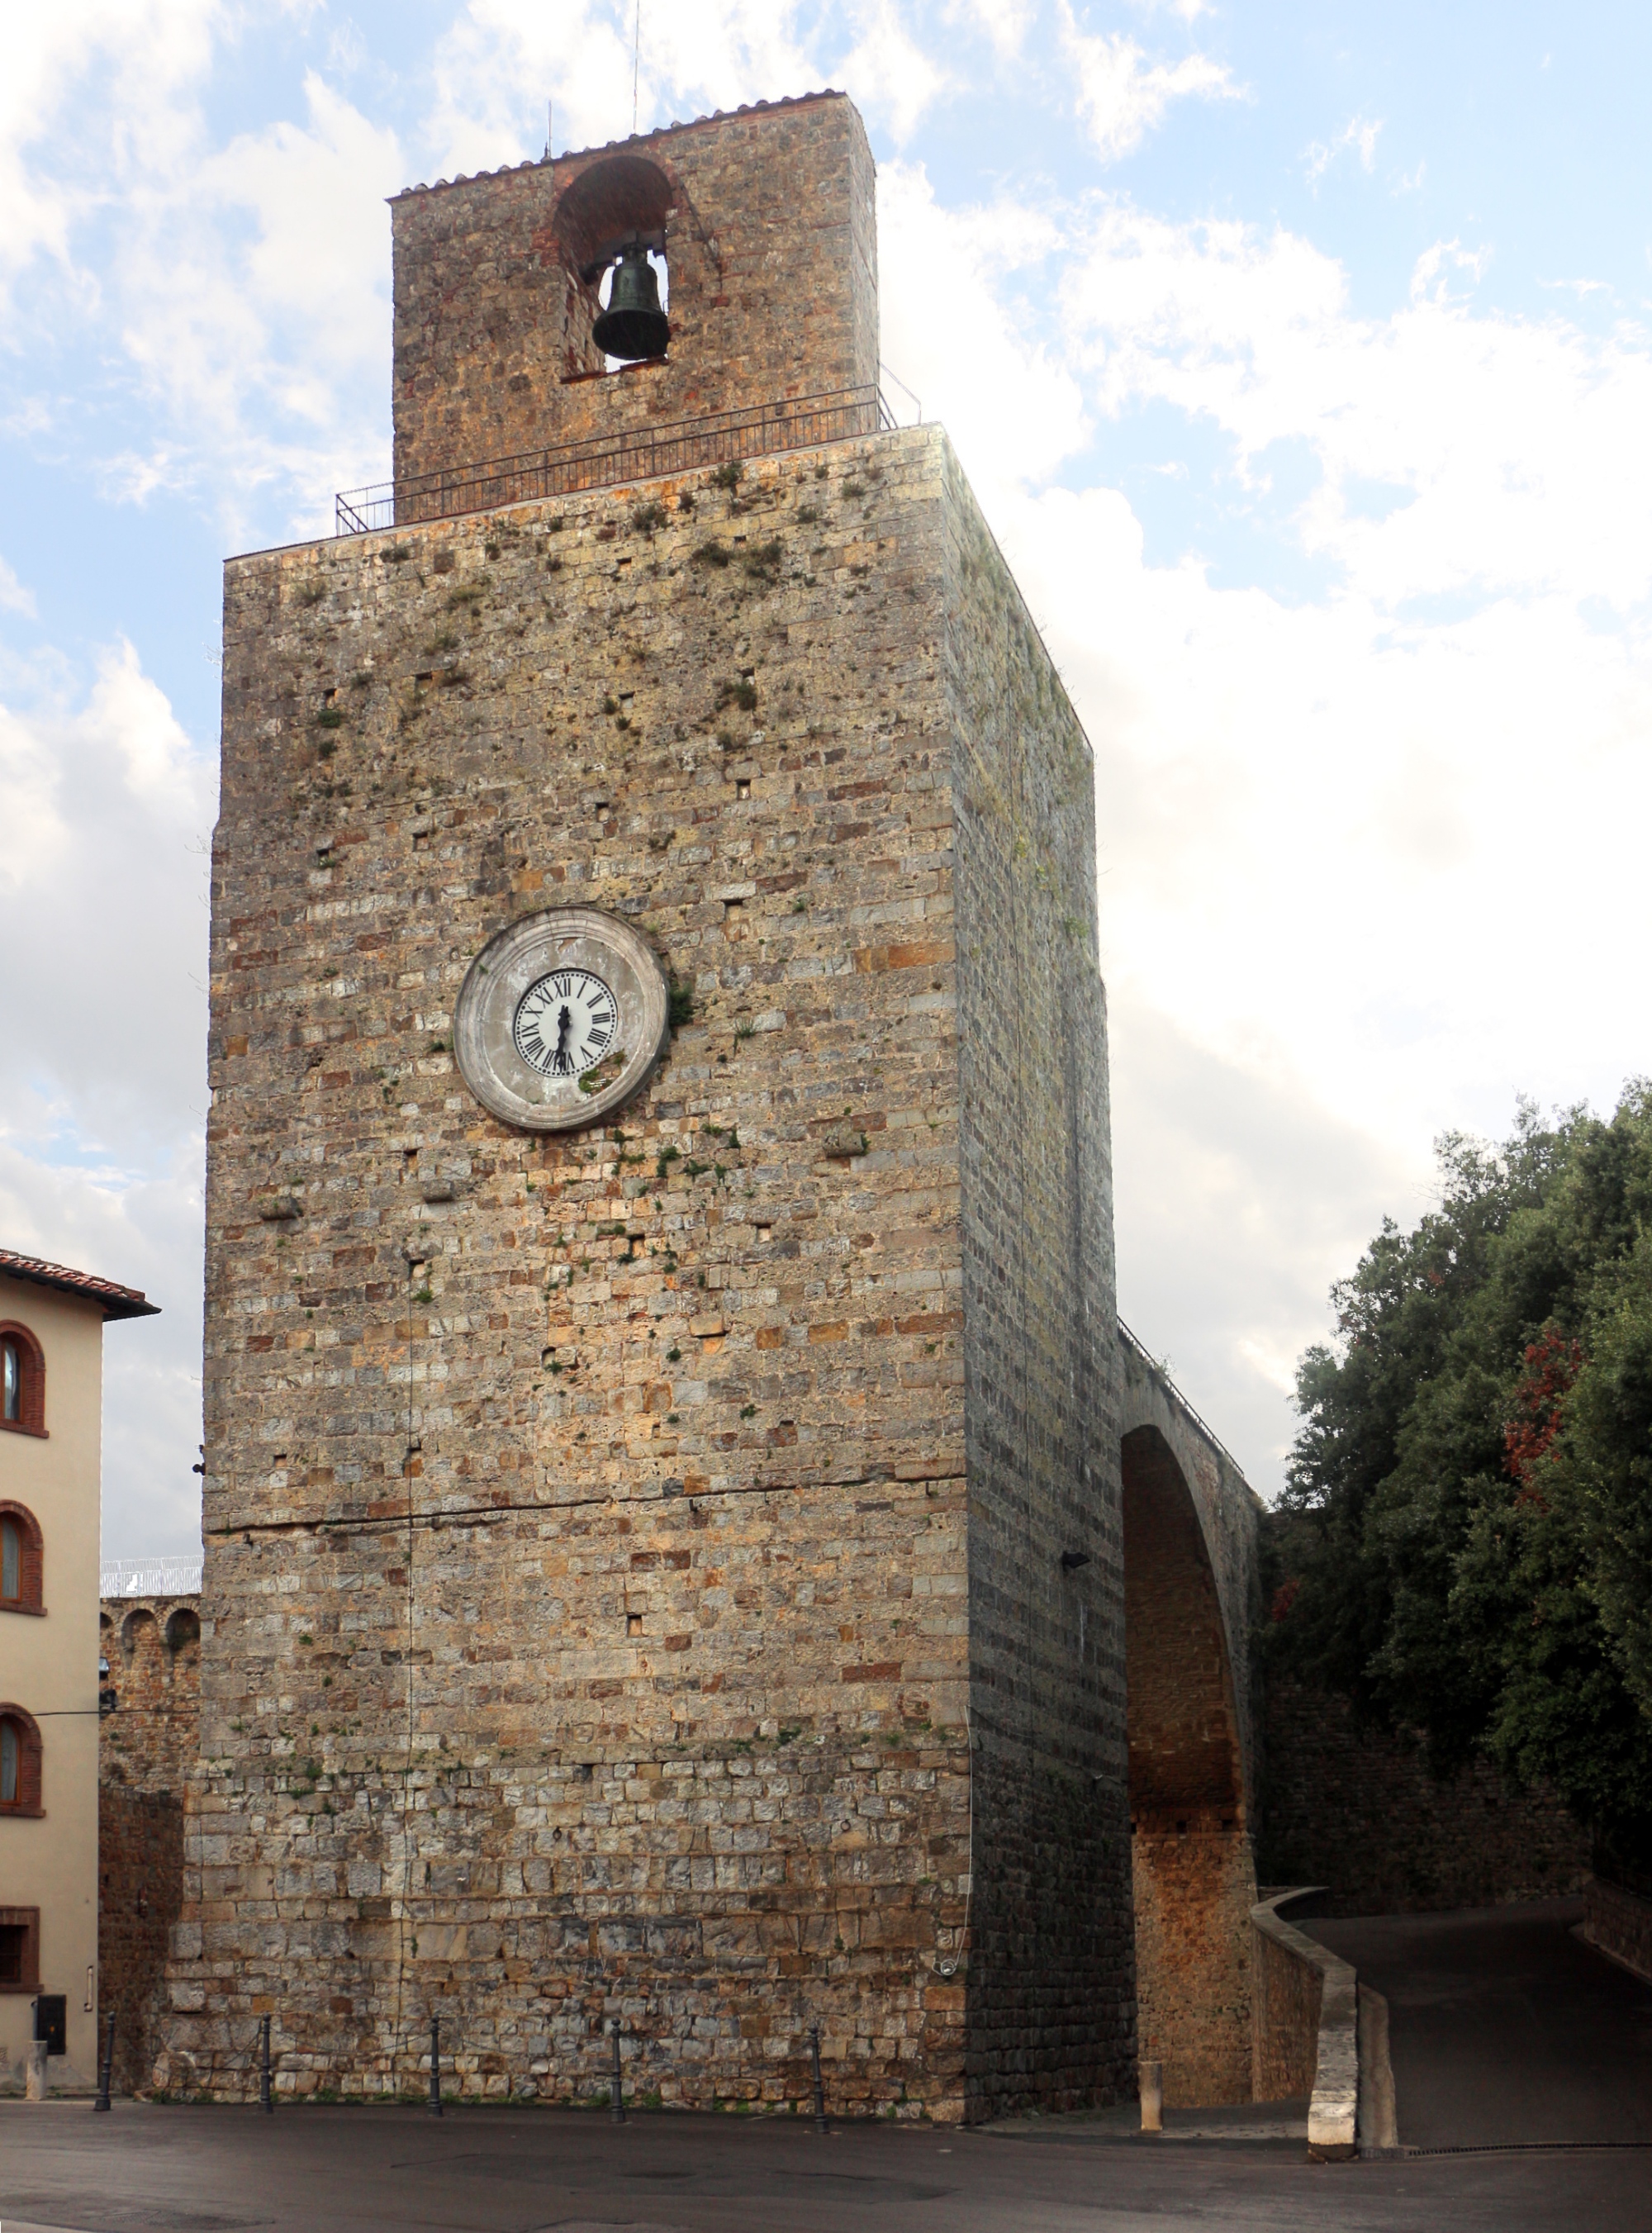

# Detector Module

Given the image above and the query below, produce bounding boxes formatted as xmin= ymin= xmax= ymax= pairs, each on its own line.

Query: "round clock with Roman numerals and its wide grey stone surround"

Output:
xmin=453 ymin=906 xmax=670 ymax=1132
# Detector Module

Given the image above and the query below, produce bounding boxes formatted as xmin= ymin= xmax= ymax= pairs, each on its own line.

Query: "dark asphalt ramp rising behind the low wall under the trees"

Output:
xmin=1299 ymin=1900 xmax=1652 ymax=2152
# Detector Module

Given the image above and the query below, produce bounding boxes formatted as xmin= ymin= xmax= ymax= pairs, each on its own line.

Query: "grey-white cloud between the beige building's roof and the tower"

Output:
xmin=0 ymin=643 xmax=214 ymax=1550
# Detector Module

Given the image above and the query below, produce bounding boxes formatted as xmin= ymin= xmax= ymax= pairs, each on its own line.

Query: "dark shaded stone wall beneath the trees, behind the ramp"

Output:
xmin=1259 ymin=1677 xmax=1589 ymax=1916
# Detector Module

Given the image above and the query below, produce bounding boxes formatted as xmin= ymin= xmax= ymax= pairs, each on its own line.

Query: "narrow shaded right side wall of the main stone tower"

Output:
xmin=944 ymin=458 xmax=1134 ymax=2108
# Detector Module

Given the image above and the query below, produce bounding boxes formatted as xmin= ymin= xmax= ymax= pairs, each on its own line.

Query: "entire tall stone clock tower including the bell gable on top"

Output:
xmin=156 ymin=94 xmax=1134 ymax=2119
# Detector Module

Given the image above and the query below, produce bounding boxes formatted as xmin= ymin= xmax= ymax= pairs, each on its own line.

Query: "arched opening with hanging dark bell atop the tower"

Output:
xmin=553 ymin=154 xmax=674 ymax=373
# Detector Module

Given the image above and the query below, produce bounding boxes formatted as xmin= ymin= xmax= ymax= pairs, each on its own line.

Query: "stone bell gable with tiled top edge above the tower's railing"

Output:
xmin=391 ymin=94 xmax=877 ymax=482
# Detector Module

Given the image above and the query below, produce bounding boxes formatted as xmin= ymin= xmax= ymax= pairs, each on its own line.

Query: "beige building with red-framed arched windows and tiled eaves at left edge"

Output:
xmin=0 ymin=1248 xmax=156 ymax=2088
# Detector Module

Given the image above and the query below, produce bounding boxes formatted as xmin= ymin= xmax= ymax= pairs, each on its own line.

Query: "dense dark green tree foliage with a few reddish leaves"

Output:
xmin=1268 ymin=1083 xmax=1652 ymax=1853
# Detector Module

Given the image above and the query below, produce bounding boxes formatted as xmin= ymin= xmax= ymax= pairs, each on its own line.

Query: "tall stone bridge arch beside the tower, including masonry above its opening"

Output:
xmin=1121 ymin=1337 xmax=1259 ymax=2106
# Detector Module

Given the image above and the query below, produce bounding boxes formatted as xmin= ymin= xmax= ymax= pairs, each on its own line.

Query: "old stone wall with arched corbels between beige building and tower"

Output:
xmin=98 ymin=1597 xmax=201 ymax=2093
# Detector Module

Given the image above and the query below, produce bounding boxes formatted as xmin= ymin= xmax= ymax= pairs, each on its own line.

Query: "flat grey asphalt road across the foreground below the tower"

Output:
xmin=0 ymin=2102 xmax=1652 ymax=2233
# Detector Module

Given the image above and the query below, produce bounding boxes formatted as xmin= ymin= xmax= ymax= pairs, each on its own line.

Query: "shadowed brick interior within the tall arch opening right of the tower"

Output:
xmin=1121 ymin=1427 xmax=1257 ymax=2106
